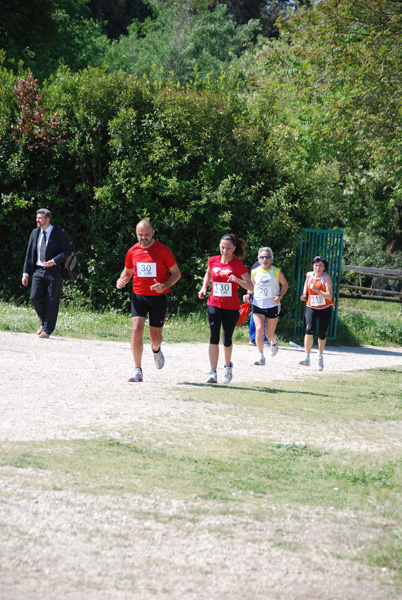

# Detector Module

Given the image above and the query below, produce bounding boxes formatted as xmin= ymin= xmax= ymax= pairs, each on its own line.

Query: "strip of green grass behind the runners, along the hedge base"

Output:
xmin=0 ymin=299 xmax=402 ymax=346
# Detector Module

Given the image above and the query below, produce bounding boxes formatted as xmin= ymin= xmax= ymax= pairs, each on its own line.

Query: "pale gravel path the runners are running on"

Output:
xmin=0 ymin=332 xmax=402 ymax=440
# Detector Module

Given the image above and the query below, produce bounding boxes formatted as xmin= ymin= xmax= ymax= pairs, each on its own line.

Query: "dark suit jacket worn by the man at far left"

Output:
xmin=23 ymin=225 xmax=72 ymax=275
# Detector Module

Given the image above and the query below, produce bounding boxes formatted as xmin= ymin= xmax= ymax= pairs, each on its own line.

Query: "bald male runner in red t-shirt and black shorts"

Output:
xmin=116 ymin=219 xmax=181 ymax=381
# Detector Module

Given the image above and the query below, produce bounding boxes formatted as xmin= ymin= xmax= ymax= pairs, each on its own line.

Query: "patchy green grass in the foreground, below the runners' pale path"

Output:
xmin=0 ymin=368 xmax=402 ymax=583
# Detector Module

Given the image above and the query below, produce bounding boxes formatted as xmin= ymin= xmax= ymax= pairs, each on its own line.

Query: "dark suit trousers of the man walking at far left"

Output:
xmin=31 ymin=267 xmax=63 ymax=334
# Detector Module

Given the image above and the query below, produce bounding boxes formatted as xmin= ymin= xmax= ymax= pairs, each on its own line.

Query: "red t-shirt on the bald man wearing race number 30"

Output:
xmin=124 ymin=240 xmax=176 ymax=296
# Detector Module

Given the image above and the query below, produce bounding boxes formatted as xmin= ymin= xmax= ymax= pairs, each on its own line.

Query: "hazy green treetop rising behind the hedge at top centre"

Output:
xmin=106 ymin=0 xmax=259 ymax=84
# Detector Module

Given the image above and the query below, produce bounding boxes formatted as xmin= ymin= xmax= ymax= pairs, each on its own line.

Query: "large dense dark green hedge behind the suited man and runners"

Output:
xmin=0 ymin=69 xmax=300 ymax=312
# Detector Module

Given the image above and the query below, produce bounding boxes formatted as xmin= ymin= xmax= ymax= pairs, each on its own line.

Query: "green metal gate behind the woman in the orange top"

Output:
xmin=294 ymin=229 xmax=343 ymax=340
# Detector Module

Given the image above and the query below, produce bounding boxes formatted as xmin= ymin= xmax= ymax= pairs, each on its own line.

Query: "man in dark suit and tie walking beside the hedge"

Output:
xmin=22 ymin=208 xmax=71 ymax=338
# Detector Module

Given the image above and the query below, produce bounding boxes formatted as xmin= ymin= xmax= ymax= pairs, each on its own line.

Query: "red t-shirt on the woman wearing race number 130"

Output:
xmin=208 ymin=256 xmax=248 ymax=310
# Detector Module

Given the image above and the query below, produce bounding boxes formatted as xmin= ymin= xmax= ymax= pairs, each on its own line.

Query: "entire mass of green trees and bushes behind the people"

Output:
xmin=0 ymin=0 xmax=402 ymax=310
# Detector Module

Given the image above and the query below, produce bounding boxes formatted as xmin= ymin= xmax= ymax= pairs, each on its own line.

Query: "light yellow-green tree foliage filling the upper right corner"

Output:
xmin=239 ymin=0 xmax=402 ymax=251
